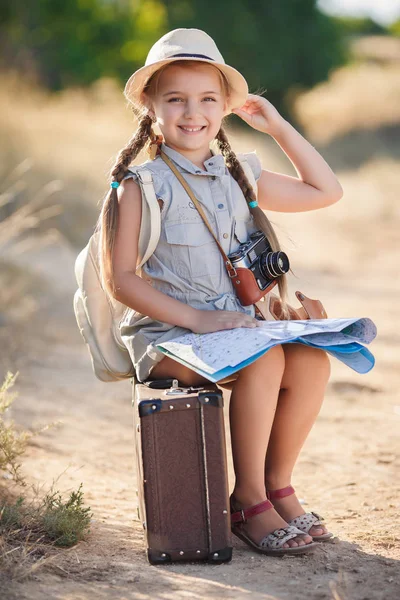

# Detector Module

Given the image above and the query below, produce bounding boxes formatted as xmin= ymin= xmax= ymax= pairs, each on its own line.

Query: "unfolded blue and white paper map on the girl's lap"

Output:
xmin=157 ymin=318 xmax=376 ymax=382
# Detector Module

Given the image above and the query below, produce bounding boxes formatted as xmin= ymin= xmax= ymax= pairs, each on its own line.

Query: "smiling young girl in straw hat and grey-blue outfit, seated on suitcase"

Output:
xmin=100 ymin=29 xmax=342 ymax=554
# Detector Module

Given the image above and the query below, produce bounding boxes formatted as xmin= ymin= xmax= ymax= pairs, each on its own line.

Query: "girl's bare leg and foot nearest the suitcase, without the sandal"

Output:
xmin=229 ymin=346 xmax=311 ymax=547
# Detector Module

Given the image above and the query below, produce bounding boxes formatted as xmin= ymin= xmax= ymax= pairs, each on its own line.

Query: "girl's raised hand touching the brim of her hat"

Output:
xmin=232 ymin=94 xmax=285 ymax=136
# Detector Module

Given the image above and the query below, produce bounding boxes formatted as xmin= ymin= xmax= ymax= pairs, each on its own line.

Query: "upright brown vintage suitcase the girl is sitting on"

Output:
xmin=132 ymin=379 xmax=232 ymax=565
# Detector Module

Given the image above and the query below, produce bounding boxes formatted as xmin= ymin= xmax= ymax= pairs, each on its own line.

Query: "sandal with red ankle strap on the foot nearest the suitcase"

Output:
xmin=230 ymin=495 xmax=315 ymax=556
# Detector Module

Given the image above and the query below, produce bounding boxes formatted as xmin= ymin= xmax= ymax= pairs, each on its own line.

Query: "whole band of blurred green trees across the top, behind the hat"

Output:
xmin=0 ymin=0 xmax=345 ymax=113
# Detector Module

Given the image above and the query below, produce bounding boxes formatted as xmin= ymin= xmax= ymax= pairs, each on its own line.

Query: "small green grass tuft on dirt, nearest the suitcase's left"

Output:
xmin=42 ymin=484 xmax=92 ymax=546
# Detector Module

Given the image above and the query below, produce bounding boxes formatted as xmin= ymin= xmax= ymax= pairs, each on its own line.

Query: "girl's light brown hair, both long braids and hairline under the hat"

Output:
xmin=97 ymin=60 xmax=288 ymax=318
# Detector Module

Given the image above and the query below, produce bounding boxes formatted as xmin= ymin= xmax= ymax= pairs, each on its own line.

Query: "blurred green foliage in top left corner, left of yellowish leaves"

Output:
xmin=1 ymin=0 xmax=130 ymax=90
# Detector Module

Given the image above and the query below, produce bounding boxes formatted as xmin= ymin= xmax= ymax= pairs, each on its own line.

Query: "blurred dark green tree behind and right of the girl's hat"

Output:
xmin=165 ymin=0 xmax=346 ymax=115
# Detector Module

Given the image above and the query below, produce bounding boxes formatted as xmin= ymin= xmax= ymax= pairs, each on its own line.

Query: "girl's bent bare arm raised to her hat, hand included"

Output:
xmin=232 ymin=94 xmax=343 ymax=212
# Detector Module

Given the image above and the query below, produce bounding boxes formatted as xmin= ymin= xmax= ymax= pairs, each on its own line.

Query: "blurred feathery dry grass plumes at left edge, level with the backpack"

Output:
xmin=0 ymin=159 xmax=66 ymax=369
